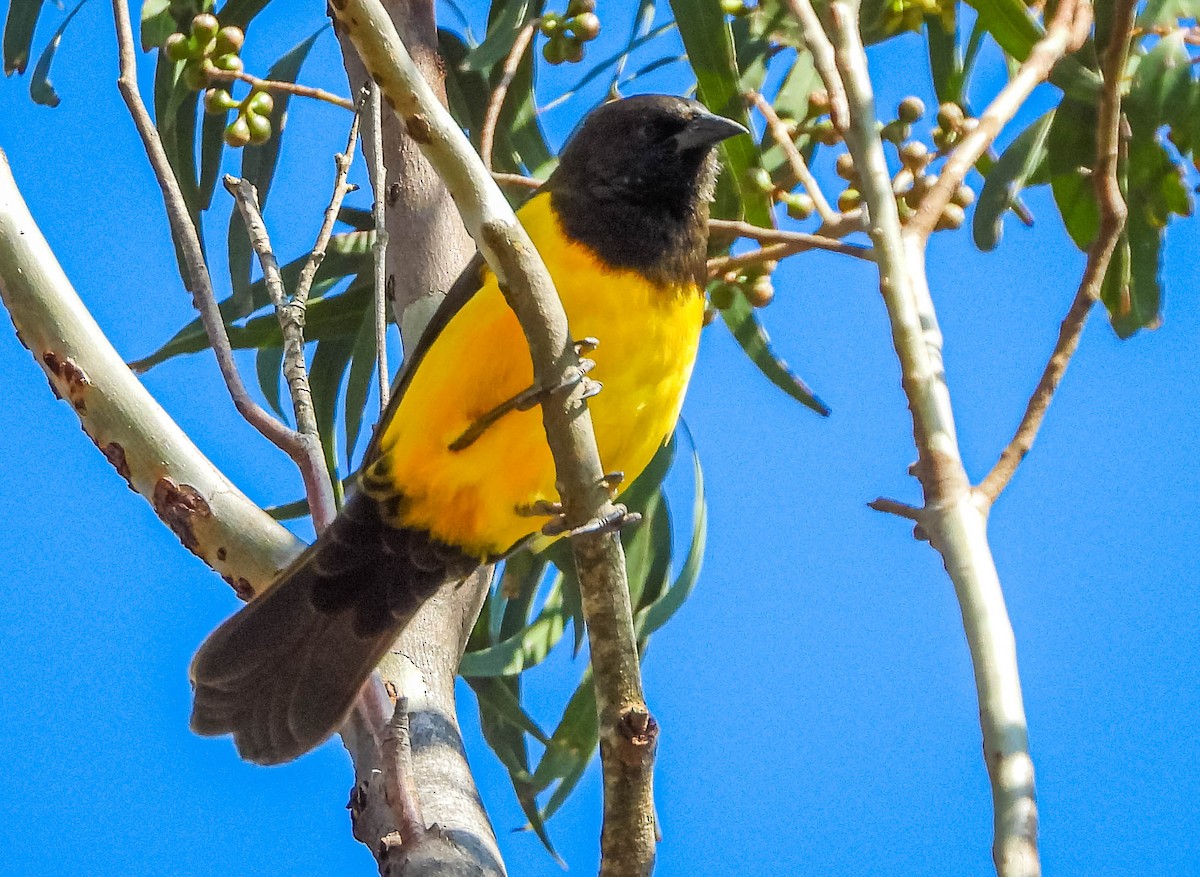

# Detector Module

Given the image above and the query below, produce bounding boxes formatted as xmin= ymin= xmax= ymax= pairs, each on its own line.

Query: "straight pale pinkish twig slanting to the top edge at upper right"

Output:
xmin=907 ymin=0 xmax=1092 ymax=238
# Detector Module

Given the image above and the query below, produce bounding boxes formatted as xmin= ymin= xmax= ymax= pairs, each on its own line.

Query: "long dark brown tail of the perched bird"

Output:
xmin=191 ymin=493 xmax=476 ymax=764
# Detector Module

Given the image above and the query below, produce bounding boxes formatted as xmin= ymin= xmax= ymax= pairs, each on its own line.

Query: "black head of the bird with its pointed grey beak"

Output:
xmin=547 ymin=95 xmax=745 ymax=282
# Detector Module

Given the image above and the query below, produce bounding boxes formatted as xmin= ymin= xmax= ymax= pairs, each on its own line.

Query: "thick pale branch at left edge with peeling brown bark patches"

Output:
xmin=0 ymin=152 xmax=304 ymax=599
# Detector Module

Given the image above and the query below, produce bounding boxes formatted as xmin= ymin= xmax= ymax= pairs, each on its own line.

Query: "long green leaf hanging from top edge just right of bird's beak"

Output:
xmin=671 ymin=0 xmax=772 ymax=228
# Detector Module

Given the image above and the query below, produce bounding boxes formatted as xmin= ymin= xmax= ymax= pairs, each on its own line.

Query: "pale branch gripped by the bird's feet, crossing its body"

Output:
xmin=335 ymin=0 xmax=658 ymax=875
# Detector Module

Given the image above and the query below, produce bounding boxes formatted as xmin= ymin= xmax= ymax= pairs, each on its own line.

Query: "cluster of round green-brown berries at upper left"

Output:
xmin=163 ymin=12 xmax=275 ymax=149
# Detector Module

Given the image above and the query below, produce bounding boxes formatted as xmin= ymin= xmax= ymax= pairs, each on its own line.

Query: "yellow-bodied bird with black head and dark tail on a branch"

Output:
xmin=190 ymin=95 xmax=748 ymax=764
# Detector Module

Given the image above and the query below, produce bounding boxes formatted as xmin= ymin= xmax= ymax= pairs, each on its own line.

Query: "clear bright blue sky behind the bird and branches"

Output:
xmin=0 ymin=2 xmax=1200 ymax=877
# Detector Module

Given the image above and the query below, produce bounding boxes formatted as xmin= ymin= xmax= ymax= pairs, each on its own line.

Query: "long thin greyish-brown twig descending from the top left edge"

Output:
xmin=113 ymin=0 xmax=329 ymax=535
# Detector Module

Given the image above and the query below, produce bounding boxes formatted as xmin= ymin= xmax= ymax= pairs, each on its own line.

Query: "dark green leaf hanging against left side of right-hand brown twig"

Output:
xmin=1046 ymin=97 xmax=1100 ymax=251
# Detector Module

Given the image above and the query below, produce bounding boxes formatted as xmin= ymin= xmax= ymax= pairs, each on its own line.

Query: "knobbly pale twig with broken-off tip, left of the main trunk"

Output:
xmin=224 ymin=175 xmax=337 ymax=533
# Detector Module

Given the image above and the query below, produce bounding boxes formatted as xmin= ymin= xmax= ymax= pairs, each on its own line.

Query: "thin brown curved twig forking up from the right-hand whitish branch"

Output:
xmin=977 ymin=0 xmax=1135 ymax=505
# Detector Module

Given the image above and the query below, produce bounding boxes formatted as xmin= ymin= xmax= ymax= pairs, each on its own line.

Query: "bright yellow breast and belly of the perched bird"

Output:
xmin=362 ymin=193 xmax=704 ymax=558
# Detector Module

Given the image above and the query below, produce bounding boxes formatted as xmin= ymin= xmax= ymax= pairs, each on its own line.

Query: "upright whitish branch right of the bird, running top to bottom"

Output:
xmin=804 ymin=0 xmax=1060 ymax=877
